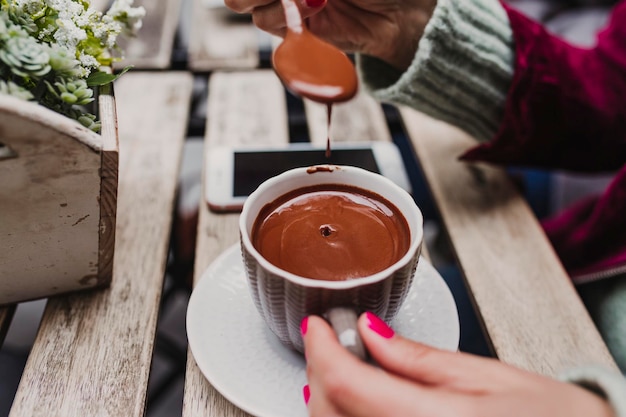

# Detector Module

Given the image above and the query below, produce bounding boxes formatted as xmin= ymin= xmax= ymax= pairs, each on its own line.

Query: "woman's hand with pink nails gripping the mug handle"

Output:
xmin=302 ymin=313 xmax=612 ymax=417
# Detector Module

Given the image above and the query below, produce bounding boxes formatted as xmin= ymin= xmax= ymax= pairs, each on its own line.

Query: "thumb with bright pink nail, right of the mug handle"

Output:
xmin=358 ymin=312 xmax=516 ymax=393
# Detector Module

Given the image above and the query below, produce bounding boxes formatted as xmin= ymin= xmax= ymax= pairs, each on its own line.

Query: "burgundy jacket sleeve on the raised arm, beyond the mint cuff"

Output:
xmin=461 ymin=0 xmax=626 ymax=172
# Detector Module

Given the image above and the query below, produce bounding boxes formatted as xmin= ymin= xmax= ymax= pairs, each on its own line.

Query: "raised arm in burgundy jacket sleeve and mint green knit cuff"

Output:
xmin=358 ymin=0 xmax=626 ymax=171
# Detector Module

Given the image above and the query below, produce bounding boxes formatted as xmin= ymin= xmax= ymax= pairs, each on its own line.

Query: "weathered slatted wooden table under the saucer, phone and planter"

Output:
xmin=0 ymin=0 xmax=615 ymax=417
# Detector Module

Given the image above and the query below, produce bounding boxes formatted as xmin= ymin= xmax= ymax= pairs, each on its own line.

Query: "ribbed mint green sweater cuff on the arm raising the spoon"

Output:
xmin=356 ymin=0 xmax=514 ymax=141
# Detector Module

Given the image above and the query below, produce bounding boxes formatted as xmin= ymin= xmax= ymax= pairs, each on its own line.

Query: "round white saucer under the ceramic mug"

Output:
xmin=187 ymin=244 xmax=459 ymax=417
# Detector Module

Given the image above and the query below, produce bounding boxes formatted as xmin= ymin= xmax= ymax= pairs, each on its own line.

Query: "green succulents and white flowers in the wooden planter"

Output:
xmin=0 ymin=0 xmax=145 ymax=131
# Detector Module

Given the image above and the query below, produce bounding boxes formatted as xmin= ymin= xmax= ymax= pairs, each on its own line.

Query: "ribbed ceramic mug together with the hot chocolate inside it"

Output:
xmin=239 ymin=165 xmax=423 ymax=357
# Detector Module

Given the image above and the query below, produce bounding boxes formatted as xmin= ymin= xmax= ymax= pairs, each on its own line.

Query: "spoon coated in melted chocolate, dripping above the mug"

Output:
xmin=272 ymin=0 xmax=357 ymax=104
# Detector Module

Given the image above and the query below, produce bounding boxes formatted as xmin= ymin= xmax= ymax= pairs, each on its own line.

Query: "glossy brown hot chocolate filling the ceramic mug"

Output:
xmin=252 ymin=184 xmax=410 ymax=281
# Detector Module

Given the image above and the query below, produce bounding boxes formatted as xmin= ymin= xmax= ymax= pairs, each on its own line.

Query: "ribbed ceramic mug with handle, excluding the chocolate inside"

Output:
xmin=239 ymin=165 xmax=423 ymax=357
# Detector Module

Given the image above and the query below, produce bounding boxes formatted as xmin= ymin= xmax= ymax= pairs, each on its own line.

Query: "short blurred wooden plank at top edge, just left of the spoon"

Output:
xmin=188 ymin=0 xmax=259 ymax=72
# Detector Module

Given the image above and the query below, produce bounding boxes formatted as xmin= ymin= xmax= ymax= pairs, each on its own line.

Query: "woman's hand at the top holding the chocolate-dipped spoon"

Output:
xmin=225 ymin=0 xmax=437 ymax=70
